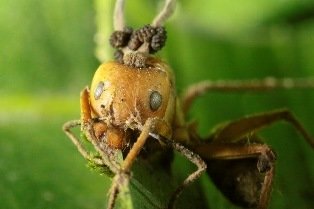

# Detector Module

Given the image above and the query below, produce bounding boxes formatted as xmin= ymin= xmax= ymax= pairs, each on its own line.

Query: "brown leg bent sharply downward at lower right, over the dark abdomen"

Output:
xmin=193 ymin=143 xmax=276 ymax=209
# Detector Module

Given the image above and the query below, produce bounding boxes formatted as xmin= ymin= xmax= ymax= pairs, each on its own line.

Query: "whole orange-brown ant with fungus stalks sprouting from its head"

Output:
xmin=63 ymin=0 xmax=314 ymax=209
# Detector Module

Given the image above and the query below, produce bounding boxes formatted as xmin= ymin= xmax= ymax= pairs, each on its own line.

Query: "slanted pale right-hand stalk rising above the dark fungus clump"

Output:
xmin=151 ymin=0 xmax=176 ymax=27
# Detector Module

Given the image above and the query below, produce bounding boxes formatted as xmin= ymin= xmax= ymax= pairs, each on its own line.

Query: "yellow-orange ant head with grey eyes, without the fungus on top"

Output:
xmin=90 ymin=58 xmax=175 ymax=128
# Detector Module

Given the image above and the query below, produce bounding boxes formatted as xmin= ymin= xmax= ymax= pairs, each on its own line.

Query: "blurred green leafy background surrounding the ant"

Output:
xmin=0 ymin=0 xmax=314 ymax=209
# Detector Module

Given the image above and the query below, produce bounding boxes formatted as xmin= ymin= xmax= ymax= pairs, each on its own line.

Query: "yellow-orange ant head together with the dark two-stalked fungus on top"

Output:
xmin=89 ymin=0 xmax=176 ymax=138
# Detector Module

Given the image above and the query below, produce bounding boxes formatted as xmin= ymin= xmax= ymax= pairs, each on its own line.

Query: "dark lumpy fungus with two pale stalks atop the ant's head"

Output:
xmin=110 ymin=0 xmax=175 ymax=68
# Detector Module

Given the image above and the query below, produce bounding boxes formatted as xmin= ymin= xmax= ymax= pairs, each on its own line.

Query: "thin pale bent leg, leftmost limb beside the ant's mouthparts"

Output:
xmin=62 ymin=120 xmax=104 ymax=166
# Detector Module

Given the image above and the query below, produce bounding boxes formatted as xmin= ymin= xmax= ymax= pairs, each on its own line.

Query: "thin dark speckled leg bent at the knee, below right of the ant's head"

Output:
xmin=150 ymin=133 xmax=207 ymax=209
